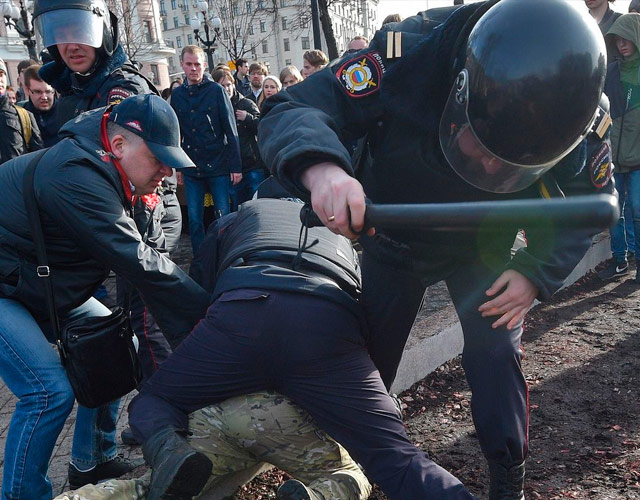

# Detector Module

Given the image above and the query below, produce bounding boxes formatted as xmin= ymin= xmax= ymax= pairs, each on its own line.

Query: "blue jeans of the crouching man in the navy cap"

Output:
xmin=0 ymin=298 xmax=120 ymax=500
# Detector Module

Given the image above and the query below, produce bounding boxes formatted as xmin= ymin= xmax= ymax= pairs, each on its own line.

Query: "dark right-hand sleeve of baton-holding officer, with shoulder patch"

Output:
xmin=507 ymin=101 xmax=614 ymax=300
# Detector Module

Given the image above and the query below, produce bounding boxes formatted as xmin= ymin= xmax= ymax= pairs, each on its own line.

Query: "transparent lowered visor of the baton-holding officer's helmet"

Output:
xmin=440 ymin=69 xmax=595 ymax=193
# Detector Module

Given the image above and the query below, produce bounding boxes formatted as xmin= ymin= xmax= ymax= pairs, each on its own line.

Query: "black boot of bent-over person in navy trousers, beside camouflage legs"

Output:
xmin=142 ymin=427 xmax=213 ymax=500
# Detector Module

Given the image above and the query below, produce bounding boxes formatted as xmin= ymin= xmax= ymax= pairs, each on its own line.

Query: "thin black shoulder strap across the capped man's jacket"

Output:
xmin=22 ymin=149 xmax=66 ymax=364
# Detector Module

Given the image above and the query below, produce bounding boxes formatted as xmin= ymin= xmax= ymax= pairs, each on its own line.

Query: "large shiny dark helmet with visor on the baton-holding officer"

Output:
xmin=440 ymin=0 xmax=606 ymax=193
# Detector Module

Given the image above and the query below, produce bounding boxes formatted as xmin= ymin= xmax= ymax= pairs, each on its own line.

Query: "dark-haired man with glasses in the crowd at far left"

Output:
xmin=23 ymin=64 xmax=60 ymax=148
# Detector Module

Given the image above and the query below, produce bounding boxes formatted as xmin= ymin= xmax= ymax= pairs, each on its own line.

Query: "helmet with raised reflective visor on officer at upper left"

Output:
xmin=33 ymin=0 xmax=118 ymax=60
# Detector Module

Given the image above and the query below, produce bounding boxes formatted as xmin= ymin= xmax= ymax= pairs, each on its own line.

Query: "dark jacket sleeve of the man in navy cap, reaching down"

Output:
xmin=35 ymin=161 xmax=209 ymax=346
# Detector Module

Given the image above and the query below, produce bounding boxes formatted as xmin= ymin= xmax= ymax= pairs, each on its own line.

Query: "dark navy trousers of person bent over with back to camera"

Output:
xmin=129 ymin=289 xmax=473 ymax=500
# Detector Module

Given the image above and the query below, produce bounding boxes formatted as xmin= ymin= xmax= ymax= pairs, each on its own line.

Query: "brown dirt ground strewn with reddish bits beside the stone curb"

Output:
xmin=235 ymin=264 xmax=640 ymax=500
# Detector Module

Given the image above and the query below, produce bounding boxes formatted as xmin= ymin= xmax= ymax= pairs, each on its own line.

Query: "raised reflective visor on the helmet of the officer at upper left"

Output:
xmin=34 ymin=9 xmax=105 ymax=48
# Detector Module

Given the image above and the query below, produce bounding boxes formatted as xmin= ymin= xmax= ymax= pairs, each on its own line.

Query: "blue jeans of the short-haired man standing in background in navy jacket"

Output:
xmin=184 ymin=175 xmax=231 ymax=255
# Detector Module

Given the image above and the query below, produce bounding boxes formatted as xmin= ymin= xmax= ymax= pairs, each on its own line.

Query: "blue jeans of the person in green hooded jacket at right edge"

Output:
xmin=610 ymin=170 xmax=640 ymax=262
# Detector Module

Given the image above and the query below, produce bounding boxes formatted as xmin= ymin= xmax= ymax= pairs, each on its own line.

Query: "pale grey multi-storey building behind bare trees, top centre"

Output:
xmin=159 ymin=0 xmax=378 ymax=77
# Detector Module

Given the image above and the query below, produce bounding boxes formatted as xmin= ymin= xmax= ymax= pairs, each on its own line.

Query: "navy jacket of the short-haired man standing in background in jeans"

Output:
xmin=171 ymin=73 xmax=242 ymax=177
